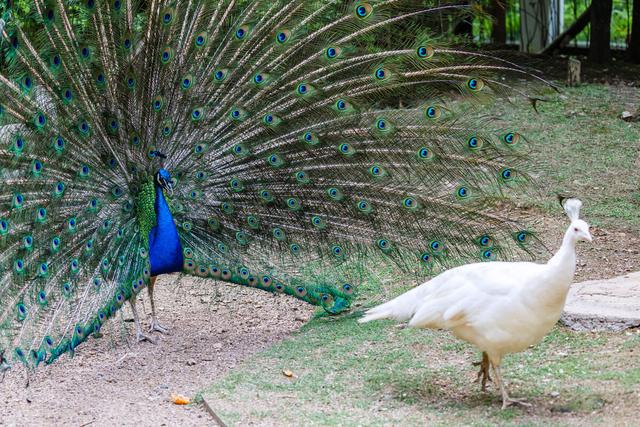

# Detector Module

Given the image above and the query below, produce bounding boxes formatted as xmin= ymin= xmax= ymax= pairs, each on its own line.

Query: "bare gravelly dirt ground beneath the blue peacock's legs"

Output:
xmin=0 ymin=275 xmax=313 ymax=426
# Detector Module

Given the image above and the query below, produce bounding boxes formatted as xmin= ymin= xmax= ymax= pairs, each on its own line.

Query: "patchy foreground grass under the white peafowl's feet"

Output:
xmin=204 ymin=304 xmax=640 ymax=426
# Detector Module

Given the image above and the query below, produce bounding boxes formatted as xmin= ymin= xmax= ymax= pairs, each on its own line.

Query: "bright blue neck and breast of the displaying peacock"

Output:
xmin=149 ymin=178 xmax=184 ymax=276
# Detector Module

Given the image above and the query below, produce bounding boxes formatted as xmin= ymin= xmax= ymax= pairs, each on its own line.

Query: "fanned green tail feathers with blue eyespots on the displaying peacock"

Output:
xmin=0 ymin=0 xmax=552 ymax=366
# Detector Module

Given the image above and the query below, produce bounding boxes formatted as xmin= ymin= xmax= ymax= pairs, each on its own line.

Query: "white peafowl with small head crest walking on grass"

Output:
xmin=359 ymin=199 xmax=591 ymax=408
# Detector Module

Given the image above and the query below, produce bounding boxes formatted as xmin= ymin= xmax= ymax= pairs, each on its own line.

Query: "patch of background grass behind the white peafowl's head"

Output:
xmin=510 ymin=85 xmax=640 ymax=232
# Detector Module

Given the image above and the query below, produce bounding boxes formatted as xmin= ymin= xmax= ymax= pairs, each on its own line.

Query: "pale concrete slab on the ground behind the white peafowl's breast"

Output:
xmin=560 ymin=271 xmax=640 ymax=331
